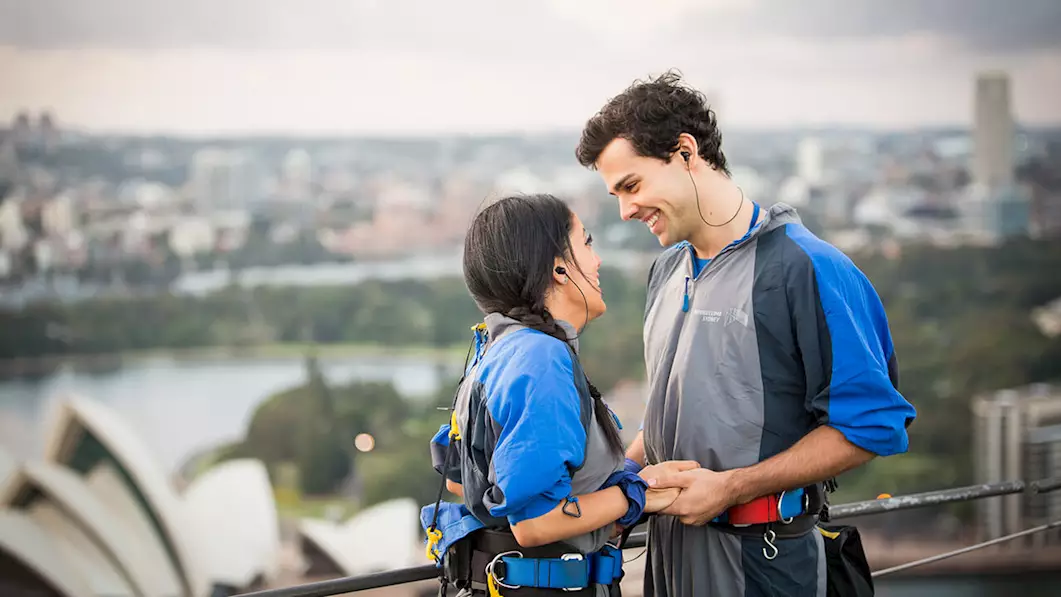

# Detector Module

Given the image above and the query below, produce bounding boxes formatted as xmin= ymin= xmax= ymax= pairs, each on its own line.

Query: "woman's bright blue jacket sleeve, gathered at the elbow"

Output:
xmin=486 ymin=336 xmax=586 ymax=524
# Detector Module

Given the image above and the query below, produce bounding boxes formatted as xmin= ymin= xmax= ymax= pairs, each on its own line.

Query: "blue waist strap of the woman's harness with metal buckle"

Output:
xmin=498 ymin=545 xmax=623 ymax=589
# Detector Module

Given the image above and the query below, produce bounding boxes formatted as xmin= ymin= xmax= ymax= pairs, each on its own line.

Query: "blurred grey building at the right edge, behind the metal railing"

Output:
xmin=973 ymin=384 xmax=1061 ymax=545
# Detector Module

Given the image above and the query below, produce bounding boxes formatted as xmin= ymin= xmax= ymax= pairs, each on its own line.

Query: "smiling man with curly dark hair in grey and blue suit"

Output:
xmin=576 ymin=73 xmax=916 ymax=597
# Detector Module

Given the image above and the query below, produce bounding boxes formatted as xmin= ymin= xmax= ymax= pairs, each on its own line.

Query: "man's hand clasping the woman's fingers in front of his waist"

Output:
xmin=648 ymin=469 xmax=736 ymax=526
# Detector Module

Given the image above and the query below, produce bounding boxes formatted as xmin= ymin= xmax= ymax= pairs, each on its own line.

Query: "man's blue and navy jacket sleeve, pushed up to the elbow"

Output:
xmin=786 ymin=224 xmax=917 ymax=456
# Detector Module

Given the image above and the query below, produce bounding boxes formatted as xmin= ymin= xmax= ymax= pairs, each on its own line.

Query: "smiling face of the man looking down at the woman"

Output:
xmin=596 ymin=139 xmax=696 ymax=246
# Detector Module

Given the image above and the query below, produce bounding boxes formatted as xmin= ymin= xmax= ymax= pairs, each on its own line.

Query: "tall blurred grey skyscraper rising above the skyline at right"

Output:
xmin=972 ymin=72 xmax=1014 ymax=190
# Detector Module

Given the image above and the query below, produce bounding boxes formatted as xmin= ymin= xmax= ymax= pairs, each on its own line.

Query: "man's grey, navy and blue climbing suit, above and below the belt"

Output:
xmin=643 ymin=204 xmax=916 ymax=597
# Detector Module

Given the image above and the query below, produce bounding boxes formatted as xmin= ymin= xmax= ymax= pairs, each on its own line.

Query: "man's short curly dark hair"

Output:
xmin=575 ymin=70 xmax=730 ymax=176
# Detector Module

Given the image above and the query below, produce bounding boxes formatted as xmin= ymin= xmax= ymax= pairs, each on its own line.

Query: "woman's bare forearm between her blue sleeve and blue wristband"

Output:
xmin=512 ymin=487 xmax=629 ymax=547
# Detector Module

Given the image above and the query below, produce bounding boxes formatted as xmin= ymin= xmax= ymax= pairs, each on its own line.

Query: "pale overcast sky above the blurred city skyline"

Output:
xmin=0 ymin=0 xmax=1061 ymax=135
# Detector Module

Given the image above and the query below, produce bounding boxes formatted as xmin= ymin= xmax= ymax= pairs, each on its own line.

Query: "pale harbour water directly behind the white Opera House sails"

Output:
xmin=0 ymin=356 xmax=459 ymax=473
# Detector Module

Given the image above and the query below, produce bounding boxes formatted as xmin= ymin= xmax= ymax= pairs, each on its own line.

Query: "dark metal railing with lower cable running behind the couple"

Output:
xmin=236 ymin=477 xmax=1061 ymax=597
